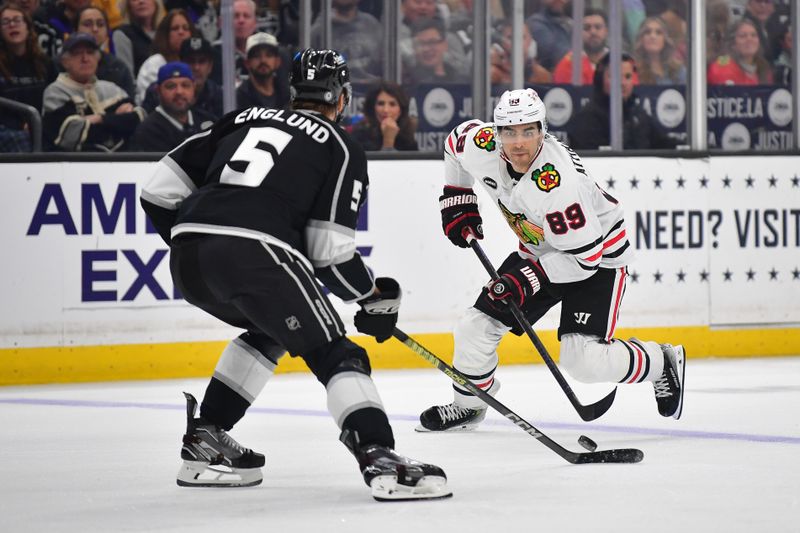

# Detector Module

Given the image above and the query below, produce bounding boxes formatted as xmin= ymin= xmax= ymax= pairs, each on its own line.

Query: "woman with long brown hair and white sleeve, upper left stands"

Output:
xmin=136 ymin=9 xmax=195 ymax=104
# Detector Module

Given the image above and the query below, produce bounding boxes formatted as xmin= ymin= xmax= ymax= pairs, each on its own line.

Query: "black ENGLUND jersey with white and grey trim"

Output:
xmin=142 ymin=107 xmax=374 ymax=301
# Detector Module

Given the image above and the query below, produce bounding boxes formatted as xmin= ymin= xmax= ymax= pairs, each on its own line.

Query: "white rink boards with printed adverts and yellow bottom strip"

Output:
xmin=0 ymin=156 xmax=800 ymax=384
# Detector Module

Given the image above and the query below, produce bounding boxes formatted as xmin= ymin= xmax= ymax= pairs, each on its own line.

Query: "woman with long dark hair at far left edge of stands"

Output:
xmin=0 ymin=3 xmax=57 ymax=152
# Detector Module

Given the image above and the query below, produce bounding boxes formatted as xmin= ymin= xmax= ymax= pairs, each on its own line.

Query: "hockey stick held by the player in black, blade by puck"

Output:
xmin=393 ymin=328 xmax=644 ymax=464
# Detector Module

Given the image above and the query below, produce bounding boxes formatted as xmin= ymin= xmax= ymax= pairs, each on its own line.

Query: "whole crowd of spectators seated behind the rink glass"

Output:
xmin=0 ymin=0 xmax=792 ymax=152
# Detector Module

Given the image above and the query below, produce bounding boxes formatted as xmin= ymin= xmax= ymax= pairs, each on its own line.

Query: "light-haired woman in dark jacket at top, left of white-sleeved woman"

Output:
xmin=111 ymin=0 xmax=165 ymax=78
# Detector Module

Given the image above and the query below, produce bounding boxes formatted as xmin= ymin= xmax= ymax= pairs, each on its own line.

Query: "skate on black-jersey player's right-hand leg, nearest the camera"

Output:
xmin=339 ymin=429 xmax=453 ymax=502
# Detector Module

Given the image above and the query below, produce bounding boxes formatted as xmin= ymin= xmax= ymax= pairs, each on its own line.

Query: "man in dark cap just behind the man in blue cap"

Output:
xmin=142 ymin=37 xmax=223 ymax=120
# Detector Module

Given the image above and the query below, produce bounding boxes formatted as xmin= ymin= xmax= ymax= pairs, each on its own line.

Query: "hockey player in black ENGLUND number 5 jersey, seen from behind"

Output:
xmin=141 ymin=50 xmax=451 ymax=500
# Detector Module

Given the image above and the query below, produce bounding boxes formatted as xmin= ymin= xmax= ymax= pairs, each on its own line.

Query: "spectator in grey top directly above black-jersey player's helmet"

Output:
xmin=311 ymin=0 xmax=383 ymax=82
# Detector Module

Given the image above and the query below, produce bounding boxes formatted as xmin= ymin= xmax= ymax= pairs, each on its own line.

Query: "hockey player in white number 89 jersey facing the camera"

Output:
xmin=418 ymin=89 xmax=686 ymax=431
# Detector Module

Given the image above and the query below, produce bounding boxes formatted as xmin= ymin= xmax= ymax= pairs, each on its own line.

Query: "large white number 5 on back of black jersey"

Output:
xmin=219 ymin=128 xmax=292 ymax=187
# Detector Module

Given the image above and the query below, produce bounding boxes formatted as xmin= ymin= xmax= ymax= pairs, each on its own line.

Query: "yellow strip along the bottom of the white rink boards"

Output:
xmin=0 ymin=326 xmax=800 ymax=385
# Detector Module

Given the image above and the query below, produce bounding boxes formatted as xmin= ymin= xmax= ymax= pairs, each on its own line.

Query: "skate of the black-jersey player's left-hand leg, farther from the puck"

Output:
xmin=178 ymin=392 xmax=264 ymax=487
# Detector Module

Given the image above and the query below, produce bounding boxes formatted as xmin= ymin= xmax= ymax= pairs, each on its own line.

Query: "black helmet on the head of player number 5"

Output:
xmin=289 ymin=48 xmax=352 ymax=114
